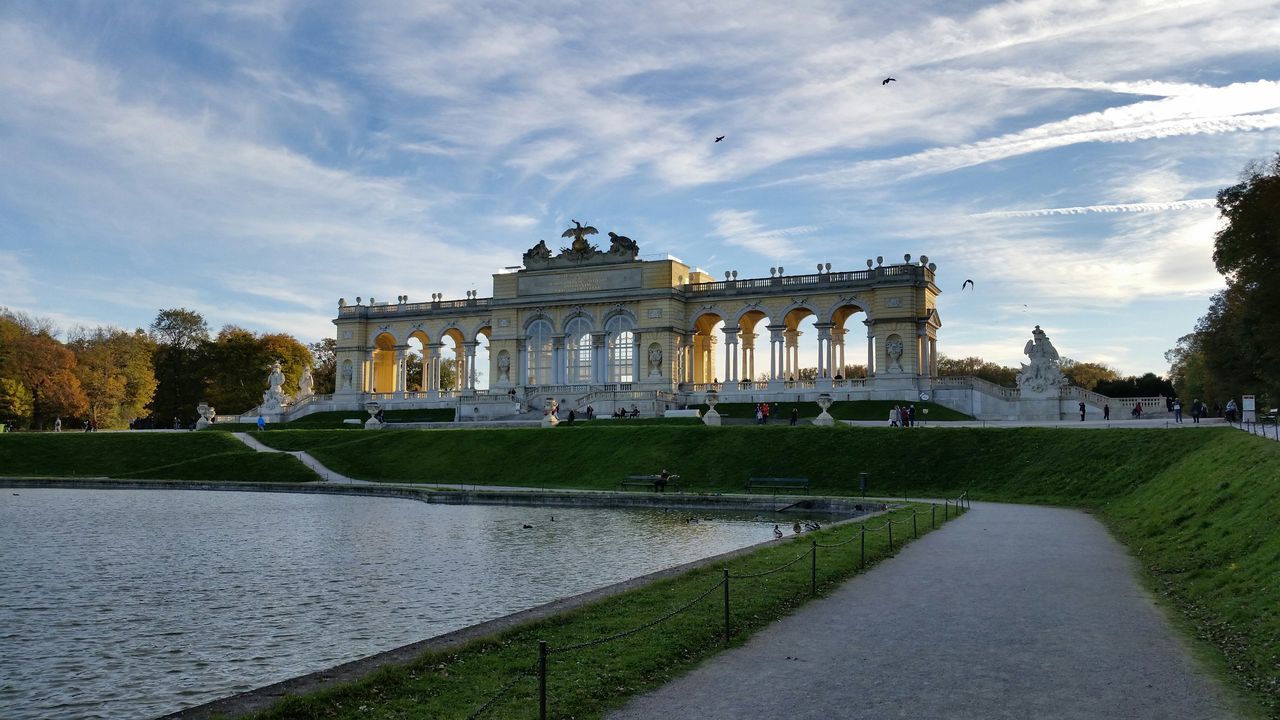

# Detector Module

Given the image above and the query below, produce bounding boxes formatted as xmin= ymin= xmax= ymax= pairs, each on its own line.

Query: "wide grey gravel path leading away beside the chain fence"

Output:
xmin=608 ymin=503 xmax=1234 ymax=720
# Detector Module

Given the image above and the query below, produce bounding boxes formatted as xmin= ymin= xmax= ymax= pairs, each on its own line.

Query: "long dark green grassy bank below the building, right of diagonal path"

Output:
xmin=255 ymin=421 xmax=1215 ymax=503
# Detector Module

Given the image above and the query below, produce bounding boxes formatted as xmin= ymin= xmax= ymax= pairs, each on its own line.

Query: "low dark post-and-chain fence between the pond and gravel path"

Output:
xmin=467 ymin=492 xmax=969 ymax=720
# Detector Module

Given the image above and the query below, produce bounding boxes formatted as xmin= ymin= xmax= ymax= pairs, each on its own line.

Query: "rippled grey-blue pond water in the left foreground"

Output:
xmin=0 ymin=489 xmax=798 ymax=720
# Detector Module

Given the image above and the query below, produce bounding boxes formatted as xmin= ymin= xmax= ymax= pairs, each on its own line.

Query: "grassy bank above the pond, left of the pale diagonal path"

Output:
xmin=0 ymin=433 xmax=316 ymax=482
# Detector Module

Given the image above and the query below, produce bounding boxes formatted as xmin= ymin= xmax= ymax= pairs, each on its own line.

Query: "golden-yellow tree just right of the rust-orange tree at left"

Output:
xmin=68 ymin=327 xmax=157 ymax=428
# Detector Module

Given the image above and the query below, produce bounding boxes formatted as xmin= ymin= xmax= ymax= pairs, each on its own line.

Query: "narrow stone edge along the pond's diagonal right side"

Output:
xmin=156 ymin=510 xmax=890 ymax=720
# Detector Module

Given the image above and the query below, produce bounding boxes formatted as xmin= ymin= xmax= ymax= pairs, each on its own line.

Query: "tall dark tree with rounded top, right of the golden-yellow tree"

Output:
xmin=151 ymin=307 xmax=209 ymax=424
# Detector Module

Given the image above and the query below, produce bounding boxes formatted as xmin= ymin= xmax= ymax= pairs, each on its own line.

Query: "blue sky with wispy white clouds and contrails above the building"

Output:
xmin=0 ymin=0 xmax=1280 ymax=374
